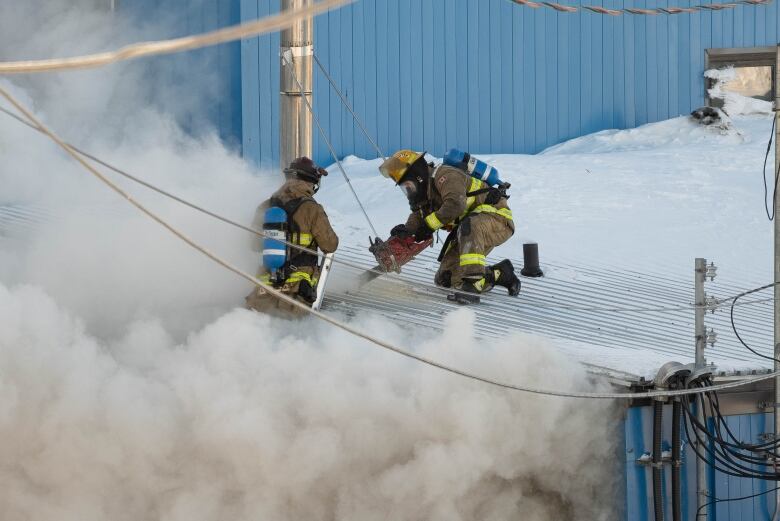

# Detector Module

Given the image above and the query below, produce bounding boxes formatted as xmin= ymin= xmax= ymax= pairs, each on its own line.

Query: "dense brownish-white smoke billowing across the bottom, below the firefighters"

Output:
xmin=0 ymin=287 xmax=619 ymax=521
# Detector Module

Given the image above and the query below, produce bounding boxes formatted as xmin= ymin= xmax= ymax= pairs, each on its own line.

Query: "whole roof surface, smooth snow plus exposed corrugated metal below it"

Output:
xmin=318 ymin=114 xmax=774 ymax=377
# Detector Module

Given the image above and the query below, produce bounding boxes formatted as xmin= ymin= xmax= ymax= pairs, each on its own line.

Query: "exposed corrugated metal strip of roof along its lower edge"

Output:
xmin=324 ymin=246 xmax=773 ymax=380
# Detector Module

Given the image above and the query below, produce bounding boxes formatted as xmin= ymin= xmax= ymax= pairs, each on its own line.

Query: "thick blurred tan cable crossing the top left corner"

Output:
xmin=0 ymin=0 xmax=355 ymax=74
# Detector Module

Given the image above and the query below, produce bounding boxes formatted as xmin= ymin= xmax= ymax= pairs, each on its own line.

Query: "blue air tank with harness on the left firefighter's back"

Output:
xmin=263 ymin=197 xmax=318 ymax=304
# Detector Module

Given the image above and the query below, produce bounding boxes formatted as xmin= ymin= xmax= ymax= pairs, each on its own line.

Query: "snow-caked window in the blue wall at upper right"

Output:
xmin=704 ymin=47 xmax=776 ymax=107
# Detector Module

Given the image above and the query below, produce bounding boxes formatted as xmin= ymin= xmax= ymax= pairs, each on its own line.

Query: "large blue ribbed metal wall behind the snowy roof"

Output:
xmin=240 ymin=0 xmax=780 ymax=165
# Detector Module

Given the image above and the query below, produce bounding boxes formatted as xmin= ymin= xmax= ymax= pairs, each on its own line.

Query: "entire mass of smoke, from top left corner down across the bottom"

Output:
xmin=0 ymin=0 xmax=621 ymax=521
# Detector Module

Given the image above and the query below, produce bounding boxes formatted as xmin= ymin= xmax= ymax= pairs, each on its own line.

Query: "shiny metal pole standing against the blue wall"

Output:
xmin=279 ymin=0 xmax=314 ymax=172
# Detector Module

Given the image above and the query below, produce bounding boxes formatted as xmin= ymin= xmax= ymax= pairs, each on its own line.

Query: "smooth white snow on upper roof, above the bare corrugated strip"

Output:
xmin=320 ymin=115 xmax=774 ymax=289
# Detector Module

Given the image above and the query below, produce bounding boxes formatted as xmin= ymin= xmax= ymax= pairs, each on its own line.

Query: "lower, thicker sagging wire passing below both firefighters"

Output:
xmin=7 ymin=86 xmax=780 ymax=400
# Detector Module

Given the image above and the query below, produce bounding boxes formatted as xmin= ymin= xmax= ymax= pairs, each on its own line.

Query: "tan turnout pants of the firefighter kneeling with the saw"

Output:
xmin=434 ymin=213 xmax=514 ymax=288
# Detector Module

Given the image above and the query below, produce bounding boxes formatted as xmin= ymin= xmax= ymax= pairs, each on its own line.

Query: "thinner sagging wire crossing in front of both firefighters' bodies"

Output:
xmin=0 ymin=100 xmax=774 ymax=313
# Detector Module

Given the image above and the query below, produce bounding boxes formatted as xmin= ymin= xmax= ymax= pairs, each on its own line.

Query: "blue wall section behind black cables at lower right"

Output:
xmin=624 ymin=406 xmax=777 ymax=521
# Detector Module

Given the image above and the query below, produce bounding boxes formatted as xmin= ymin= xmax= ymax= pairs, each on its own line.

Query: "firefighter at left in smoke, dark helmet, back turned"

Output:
xmin=246 ymin=157 xmax=339 ymax=316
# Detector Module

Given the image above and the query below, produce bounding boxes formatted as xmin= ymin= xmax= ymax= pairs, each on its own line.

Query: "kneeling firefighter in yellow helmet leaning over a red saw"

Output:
xmin=379 ymin=150 xmax=520 ymax=304
